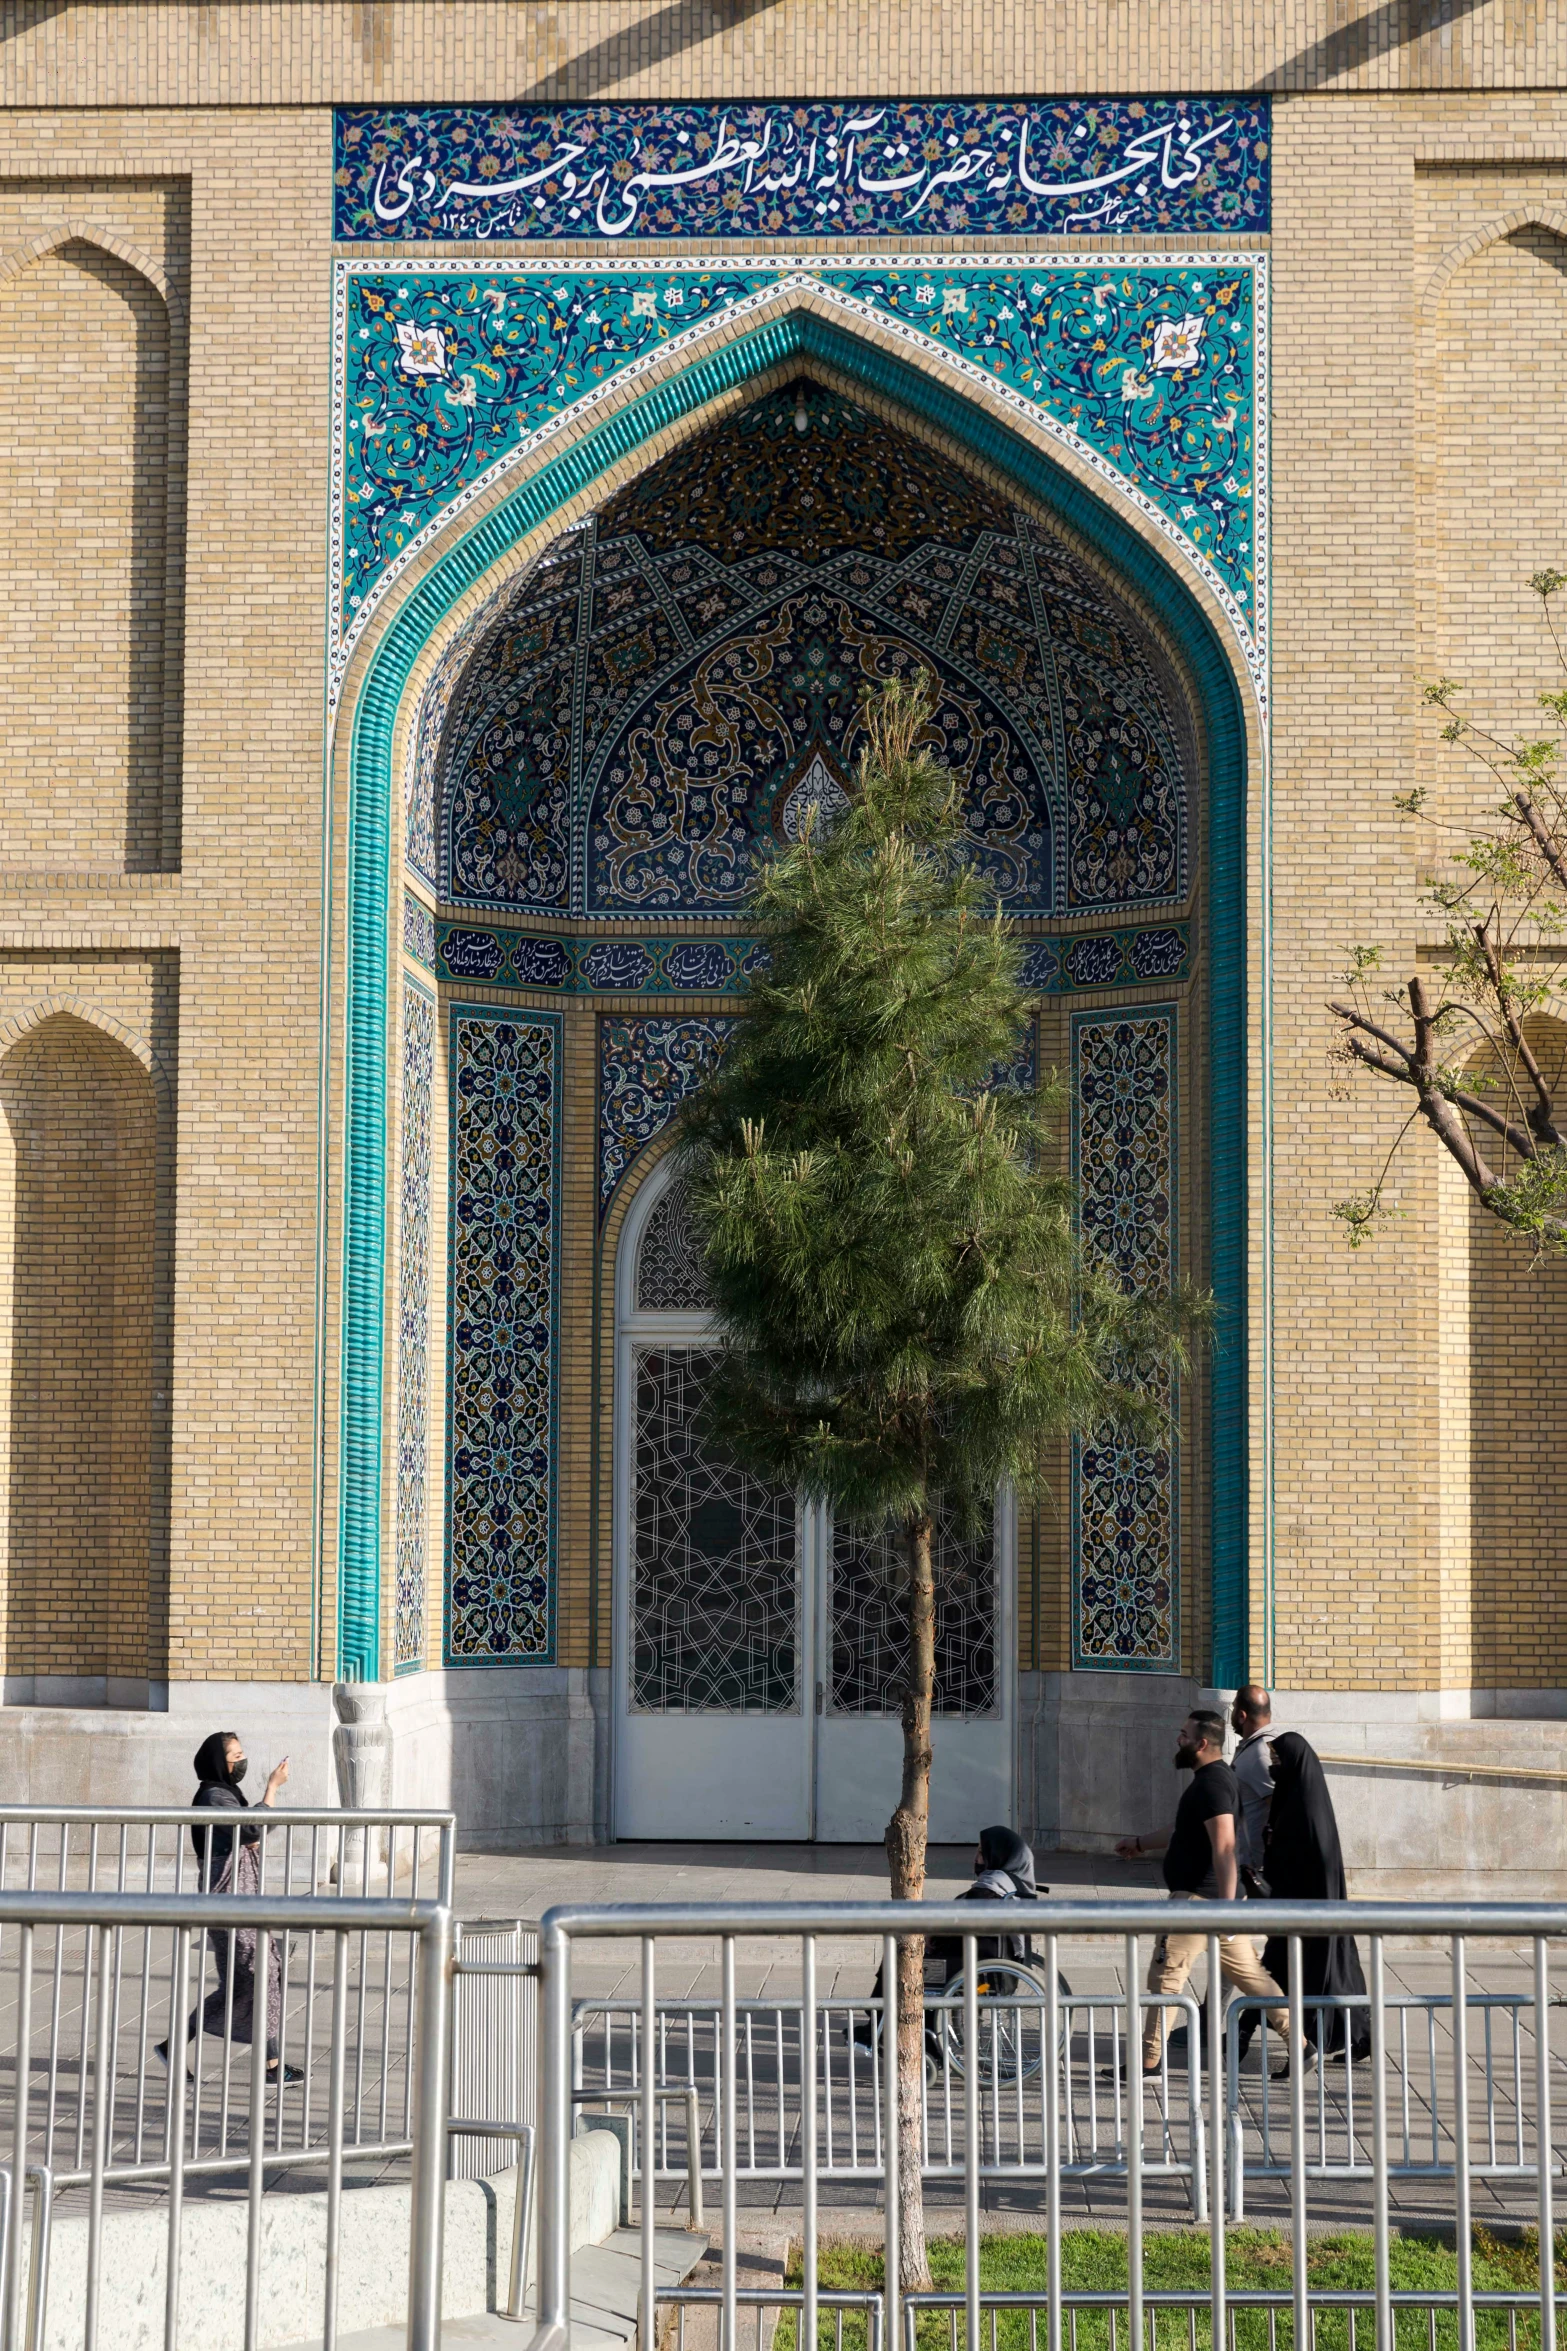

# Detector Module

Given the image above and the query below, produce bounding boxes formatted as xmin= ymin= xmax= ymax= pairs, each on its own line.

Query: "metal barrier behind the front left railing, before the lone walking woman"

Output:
xmin=0 ymin=1806 xmax=456 ymax=2193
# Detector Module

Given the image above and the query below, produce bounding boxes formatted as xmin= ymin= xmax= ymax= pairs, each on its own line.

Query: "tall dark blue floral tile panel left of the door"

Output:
xmin=446 ymin=1004 xmax=561 ymax=1665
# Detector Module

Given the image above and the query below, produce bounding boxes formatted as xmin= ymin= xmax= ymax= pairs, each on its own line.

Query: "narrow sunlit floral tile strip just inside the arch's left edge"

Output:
xmin=392 ymin=978 xmax=435 ymax=1674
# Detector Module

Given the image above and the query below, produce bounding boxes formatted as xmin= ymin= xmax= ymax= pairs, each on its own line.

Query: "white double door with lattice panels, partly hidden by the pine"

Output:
xmin=613 ymin=1310 xmax=1015 ymax=1843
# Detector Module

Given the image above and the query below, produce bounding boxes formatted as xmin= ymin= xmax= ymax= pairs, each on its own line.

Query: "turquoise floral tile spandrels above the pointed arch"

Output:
xmin=329 ymin=252 xmax=1266 ymax=719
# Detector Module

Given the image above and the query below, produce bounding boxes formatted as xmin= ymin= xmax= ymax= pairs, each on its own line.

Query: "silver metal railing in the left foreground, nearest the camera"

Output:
xmin=0 ymin=1880 xmax=453 ymax=2351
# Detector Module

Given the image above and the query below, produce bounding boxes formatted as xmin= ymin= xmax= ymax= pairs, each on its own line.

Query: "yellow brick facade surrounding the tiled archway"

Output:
xmin=0 ymin=0 xmax=1567 ymax=1852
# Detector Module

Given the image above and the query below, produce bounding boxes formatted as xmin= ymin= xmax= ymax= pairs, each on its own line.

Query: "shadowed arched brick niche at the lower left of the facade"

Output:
xmin=0 ymin=1013 xmax=169 ymax=1704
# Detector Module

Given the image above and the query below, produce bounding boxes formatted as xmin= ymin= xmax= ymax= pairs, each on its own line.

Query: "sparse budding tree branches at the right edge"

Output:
xmin=1327 ymin=571 xmax=1567 ymax=1251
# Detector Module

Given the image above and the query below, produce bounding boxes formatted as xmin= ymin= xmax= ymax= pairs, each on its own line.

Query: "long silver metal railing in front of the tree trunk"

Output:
xmin=536 ymin=1900 xmax=1567 ymax=2351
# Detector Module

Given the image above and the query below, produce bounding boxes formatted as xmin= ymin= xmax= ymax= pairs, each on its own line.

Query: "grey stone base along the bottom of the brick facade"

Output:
xmin=0 ymin=1667 xmax=1567 ymax=1902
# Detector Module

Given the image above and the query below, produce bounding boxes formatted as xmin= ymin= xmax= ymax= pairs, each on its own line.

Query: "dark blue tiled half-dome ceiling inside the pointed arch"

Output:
xmin=422 ymin=379 xmax=1191 ymax=917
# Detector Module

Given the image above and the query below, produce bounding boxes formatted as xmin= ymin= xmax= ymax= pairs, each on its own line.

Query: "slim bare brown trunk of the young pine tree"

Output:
xmin=886 ymin=1514 xmax=935 ymax=2292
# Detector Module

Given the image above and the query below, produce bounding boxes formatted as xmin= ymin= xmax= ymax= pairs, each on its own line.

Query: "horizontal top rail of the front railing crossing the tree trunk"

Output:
xmin=542 ymin=1895 xmax=1567 ymax=1947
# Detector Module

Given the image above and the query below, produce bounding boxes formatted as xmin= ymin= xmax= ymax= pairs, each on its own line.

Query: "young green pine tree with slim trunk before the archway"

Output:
xmin=681 ymin=679 xmax=1205 ymax=2285
